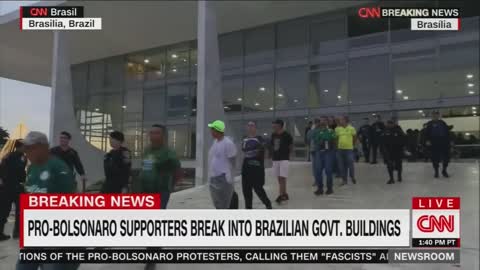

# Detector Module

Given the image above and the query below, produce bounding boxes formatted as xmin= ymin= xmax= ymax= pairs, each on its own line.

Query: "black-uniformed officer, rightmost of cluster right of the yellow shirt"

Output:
xmin=380 ymin=120 xmax=406 ymax=184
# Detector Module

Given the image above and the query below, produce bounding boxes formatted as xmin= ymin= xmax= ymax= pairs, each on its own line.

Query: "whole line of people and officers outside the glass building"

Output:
xmin=0 ymin=112 xmax=458 ymax=269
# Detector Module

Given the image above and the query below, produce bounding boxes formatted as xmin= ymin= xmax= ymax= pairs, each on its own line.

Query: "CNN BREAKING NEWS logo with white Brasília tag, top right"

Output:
xmin=358 ymin=7 xmax=461 ymax=31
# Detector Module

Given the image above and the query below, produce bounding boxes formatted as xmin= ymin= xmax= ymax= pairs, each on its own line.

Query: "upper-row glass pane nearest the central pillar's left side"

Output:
xmin=167 ymin=44 xmax=190 ymax=79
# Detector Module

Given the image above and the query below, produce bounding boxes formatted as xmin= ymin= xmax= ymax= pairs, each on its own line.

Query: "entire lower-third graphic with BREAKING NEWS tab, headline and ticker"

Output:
xmin=19 ymin=194 xmax=460 ymax=264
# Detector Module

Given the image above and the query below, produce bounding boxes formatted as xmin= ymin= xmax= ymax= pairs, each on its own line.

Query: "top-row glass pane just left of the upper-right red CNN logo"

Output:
xmin=310 ymin=17 xmax=347 ymax=55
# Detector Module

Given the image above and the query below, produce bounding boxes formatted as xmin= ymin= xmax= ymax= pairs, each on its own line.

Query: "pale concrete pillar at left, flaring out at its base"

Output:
xmin=50 ymin=31 xmax=104 ymax=188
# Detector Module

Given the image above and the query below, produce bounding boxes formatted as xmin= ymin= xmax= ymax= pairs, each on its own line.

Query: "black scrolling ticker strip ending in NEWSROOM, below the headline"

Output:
xmin=19 ymin=248 xmax=460 ymax=264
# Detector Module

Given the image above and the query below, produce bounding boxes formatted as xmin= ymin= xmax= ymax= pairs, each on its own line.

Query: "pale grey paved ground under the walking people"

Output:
xmin=0 ymin=162 xmax=479 ymax=270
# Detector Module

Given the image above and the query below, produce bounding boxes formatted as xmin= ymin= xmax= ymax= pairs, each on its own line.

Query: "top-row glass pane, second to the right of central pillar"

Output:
xmin=245 ymin=25 xmax=275 ymax=66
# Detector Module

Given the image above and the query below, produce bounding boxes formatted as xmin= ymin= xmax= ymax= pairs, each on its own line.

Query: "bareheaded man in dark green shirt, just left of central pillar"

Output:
xmin=140 ymin=125 xmax=182 ymax=209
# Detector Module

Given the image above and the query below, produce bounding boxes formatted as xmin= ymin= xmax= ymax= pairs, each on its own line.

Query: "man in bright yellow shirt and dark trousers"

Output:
xmin=335 ymin=116 xmax=357 ymax=185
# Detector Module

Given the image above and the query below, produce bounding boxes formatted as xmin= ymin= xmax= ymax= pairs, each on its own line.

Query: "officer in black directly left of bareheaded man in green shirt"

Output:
xmin=102 ymin=131 xmax=132 ymax=193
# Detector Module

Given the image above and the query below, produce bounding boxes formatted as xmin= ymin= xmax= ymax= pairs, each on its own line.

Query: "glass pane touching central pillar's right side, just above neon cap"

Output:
xmin=222 ymin=76 xmax=243 ymax=113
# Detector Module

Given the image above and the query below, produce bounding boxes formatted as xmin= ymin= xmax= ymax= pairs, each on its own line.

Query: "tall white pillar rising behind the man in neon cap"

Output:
xmin=195 ymin=1 xmax=228 ymax=185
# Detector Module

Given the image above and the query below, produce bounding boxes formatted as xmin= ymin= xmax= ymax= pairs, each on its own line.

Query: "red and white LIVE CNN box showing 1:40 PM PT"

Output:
xmin=412 ymin=197 xmax=460 ymax=247
